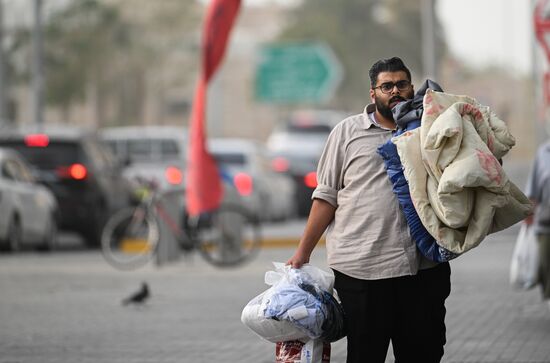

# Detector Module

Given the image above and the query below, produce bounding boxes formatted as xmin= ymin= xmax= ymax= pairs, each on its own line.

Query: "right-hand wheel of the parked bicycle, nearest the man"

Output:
xmin=193 ymin=205 xmax=262 ymax=267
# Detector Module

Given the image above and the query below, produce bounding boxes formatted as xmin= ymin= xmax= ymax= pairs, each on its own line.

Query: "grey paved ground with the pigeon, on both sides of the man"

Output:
xmin=0 ymin=223 xmax=550 ymax=363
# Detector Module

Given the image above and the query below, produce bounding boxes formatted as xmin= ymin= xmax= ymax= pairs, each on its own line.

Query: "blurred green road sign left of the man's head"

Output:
xmin=255 ymin=43 xmax=342 ymax=103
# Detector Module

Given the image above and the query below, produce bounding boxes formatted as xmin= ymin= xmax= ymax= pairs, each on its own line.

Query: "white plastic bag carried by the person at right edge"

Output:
xmin=510 ymin=223 xmax=539 ymax=290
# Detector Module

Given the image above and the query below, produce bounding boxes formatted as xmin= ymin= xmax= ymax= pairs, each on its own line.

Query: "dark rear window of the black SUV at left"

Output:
xmin=2 ymin=142 xmax=82 ymax=170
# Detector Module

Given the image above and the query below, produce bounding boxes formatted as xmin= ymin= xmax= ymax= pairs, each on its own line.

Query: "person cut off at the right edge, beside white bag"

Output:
xmin=525 ymin=141 xmax=550 ymax=309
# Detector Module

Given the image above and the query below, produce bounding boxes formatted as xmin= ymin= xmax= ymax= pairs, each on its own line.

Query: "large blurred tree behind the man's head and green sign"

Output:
xmin=278 ymin=0 xmax=446 ymax=110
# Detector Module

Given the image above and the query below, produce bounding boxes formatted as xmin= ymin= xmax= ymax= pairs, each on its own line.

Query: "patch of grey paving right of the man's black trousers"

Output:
xmin=444 ymin=228 xmax=550 ymax=363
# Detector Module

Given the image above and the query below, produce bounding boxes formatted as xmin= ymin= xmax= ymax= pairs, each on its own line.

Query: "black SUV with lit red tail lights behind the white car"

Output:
xmin=0 ymin=125 xmax=131 ymax=246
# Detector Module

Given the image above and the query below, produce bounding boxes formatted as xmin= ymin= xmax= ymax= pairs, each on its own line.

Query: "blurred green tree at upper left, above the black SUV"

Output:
xmin=10 ymin=0 xmax=200 ymax=127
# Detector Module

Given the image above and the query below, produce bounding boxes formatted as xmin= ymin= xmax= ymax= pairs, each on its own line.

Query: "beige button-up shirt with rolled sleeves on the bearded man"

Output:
xmin=312 ymin=105 xmax=421 ymax=280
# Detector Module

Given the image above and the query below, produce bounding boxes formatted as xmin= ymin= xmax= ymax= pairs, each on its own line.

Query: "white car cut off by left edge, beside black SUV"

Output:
xmin=0 ymin=148 xmax=58 ymax=251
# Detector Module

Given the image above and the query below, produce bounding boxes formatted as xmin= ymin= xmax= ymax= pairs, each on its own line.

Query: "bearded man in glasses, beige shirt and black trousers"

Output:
xmin=287 ymin=57 xmax=450 ymax=363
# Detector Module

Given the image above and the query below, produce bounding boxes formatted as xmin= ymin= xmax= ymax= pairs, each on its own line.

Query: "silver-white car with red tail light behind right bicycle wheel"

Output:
xmin=208 ymin=138 xmax=296 ymax=220
